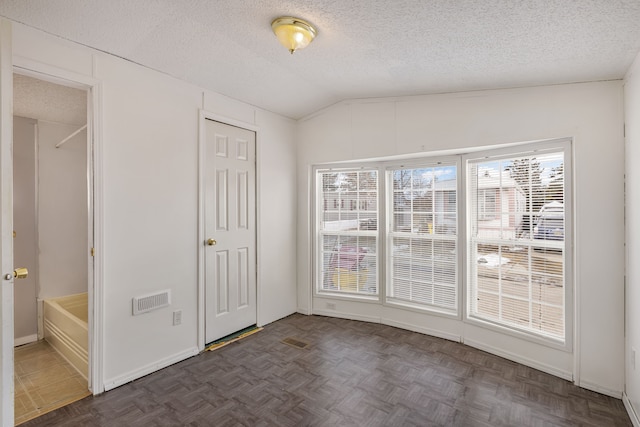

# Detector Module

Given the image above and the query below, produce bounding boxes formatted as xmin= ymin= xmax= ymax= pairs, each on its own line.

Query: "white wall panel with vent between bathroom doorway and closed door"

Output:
xmin=95 ymin=55 xmax=201 ymax=383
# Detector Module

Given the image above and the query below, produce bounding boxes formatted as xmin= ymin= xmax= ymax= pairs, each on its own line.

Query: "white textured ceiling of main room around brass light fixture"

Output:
xmin=0 ymin=0 xmax=640 ymax=118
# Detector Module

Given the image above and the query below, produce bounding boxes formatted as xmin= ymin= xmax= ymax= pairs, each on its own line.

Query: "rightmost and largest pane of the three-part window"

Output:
xmin=467 ymin=151 xmax=567 ymax=342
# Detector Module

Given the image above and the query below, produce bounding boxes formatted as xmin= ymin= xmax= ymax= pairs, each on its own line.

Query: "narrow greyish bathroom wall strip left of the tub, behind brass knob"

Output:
xmin=13 ymin=116 xmax=38 ymax=345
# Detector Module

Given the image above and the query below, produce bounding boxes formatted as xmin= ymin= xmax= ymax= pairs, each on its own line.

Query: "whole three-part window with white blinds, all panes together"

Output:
xmin=314 ymin=141 xmax=572 ymax=348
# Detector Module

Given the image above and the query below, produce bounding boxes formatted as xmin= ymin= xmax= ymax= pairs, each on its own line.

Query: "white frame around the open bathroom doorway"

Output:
xmin=2 ymin=37 xmax=104 ymax=417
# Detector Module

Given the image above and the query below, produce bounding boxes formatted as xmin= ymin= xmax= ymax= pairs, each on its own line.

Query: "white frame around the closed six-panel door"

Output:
xmin=198 ymin=110 xmax=262 ymax=351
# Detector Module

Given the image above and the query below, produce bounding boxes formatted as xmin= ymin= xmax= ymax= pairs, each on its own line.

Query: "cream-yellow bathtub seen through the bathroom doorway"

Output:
xmin=43 ymin=292 xmax=89 ymax=379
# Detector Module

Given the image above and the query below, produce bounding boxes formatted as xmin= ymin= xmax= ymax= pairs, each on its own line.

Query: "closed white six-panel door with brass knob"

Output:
xmin=204 ymin=120 xmax=257 ymax=343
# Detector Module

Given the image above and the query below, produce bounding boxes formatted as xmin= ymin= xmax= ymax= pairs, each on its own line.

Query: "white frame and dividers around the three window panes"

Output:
xmin=311 ymin=138 xmax=575 ymax=352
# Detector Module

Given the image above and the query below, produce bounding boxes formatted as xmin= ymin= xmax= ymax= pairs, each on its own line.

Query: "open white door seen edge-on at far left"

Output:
xmin=0 ymin=18 xmax=14 ymax=426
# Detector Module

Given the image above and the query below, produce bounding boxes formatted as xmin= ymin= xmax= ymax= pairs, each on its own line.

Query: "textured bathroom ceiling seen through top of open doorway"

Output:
xmin=13 ymin=74 xmax=87 ymax=127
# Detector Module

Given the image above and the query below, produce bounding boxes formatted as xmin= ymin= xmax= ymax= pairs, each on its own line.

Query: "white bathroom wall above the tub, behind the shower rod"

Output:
xmin=37 ymin=120 xmax=89 ymax=299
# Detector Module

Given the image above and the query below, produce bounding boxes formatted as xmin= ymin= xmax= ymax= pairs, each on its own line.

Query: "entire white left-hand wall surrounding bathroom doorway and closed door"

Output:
xmin=13 ymin=23 xmax=296 ymax=388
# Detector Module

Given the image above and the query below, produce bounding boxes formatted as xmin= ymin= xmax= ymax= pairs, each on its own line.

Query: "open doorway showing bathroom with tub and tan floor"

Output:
xmin=13 ymin=73 xmax=93 ymax=424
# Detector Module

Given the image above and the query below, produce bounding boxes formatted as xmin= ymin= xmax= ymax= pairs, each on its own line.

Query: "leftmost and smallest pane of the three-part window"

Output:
xmin=317 ymin=170 xmax=378 ymax=295
